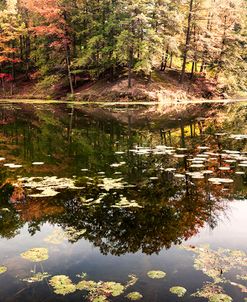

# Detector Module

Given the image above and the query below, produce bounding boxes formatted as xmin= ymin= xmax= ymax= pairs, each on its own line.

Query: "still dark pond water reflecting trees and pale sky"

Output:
xmin=0 ymin=104 xmax=247 ymax=302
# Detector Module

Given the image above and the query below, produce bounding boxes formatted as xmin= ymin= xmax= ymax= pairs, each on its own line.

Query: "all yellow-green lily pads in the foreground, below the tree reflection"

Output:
xmin=0 ymin=227 xmax=247 ymax=302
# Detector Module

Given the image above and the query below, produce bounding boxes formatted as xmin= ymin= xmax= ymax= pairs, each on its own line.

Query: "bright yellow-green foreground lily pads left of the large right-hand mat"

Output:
xmin=0 ymin=244 xmax=186 ymax=302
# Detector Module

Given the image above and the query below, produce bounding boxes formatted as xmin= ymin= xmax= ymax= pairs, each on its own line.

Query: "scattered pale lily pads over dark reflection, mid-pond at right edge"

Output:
xmin=126 ymin=139 xmax=247 ymax=185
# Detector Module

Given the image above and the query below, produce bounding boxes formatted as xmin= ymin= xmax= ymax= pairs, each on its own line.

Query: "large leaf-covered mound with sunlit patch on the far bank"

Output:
xmin=72 ymin=69 xmax=222 ymax=102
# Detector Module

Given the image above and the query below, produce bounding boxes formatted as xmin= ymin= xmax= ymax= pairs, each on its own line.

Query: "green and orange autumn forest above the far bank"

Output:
xmin=0 ymin=0 xmax=247 ymax=98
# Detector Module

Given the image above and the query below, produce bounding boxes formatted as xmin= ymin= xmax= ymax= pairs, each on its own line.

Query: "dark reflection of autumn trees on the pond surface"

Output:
xmin=0 ymin=105 xmax=246 ymax=255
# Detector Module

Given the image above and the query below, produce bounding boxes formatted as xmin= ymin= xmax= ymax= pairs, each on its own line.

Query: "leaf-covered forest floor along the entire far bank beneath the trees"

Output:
xmin=0 ymin=69 xmax=227 ymax=103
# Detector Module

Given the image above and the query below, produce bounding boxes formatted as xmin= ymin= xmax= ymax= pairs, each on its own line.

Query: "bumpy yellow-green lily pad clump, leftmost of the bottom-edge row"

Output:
xmin=49 ymin=275 xmax=76 ymax=296
